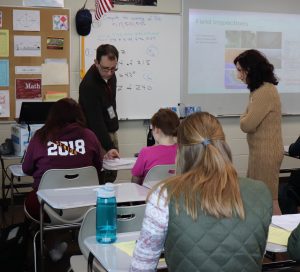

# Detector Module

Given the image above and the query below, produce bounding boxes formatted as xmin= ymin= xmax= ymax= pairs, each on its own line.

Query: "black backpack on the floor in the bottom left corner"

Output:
xmin=0 ymin=223 xmax=28 ymax=272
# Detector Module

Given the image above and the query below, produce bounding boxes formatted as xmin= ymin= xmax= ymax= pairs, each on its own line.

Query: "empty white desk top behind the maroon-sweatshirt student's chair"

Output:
xmin=37 ymin=183 xmax=149 ymax=209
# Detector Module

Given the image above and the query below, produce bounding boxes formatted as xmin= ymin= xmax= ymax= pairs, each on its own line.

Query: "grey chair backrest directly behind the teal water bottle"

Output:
xmin=78 ymin=203 xmax=146 ymax=258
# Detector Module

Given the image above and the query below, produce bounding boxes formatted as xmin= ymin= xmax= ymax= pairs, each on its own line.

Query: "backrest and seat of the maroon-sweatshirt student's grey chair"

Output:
xmin=39 ymin=166 xmax=99 ymax=224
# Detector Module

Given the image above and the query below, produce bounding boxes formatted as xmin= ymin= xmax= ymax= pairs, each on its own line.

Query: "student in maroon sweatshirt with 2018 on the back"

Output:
xmin=22 ymin=98 xmax=119 ymax=219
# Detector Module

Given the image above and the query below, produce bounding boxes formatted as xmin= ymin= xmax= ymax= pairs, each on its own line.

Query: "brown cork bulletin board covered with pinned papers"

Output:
xmin=0 ymin=6 xmax=70 ymax=120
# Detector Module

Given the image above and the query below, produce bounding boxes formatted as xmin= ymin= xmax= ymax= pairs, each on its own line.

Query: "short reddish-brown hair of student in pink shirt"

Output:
xmin=150 ymin=109 xmax=180 ymax=136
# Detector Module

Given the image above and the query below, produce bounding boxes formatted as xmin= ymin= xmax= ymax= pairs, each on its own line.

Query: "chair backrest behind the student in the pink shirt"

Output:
xmin=143 ymin=164 xmax=176 ymax=189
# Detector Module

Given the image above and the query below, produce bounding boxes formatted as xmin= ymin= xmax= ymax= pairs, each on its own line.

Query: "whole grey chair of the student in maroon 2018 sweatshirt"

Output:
xmin=24 ymin=166 xmax=99 ymax=271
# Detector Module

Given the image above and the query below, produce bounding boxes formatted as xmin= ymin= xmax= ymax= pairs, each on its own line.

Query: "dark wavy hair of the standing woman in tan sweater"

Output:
xmin=233 ymin=49 xmax=278 ymax=92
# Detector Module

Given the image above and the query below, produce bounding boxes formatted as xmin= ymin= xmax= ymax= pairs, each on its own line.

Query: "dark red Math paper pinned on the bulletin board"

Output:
xmin=16 ymin=78 xmax=42 ymax=99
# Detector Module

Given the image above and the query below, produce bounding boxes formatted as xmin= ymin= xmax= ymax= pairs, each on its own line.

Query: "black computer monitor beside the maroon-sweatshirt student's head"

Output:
xmin=18 ymin=102 xmax=55 ymax=124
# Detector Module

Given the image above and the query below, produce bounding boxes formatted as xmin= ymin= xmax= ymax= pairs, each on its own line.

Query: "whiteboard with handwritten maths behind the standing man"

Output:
xmin=80 ymin=12 xmax=181 ymax=119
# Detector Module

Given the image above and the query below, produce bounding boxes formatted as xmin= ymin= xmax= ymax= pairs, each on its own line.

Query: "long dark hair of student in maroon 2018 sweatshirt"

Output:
xmin=36 ymin=98 xmax=86 ymax=143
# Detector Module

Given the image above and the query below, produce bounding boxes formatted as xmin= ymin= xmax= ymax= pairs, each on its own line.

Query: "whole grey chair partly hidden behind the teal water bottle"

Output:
xmin=70 ymin=204 xmax=146 ymax=272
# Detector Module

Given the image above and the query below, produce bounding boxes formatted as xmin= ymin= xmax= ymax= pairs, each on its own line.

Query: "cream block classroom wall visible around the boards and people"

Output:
xmin=0 ymin=0 xmax=300 ymax=183
